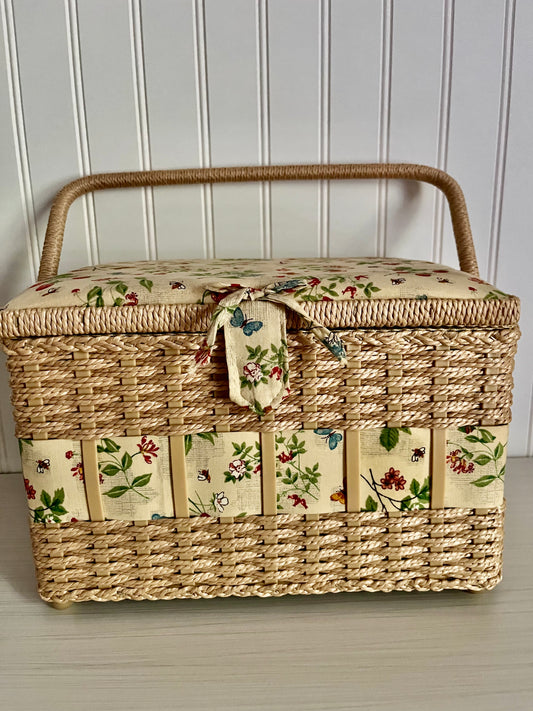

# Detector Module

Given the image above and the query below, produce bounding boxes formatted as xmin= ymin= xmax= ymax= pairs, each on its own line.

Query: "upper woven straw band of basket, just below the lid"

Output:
xmin=7 ymin=327 xmax=519 ymax=439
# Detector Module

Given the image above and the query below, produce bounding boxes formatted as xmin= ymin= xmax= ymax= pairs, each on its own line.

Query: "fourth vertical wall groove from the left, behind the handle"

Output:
xmin=193 ymin=0 xmax=215 ymax=259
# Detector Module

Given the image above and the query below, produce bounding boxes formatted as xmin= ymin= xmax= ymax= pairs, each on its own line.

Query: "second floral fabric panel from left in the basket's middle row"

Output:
xmin=97 ymin=436 xmax=170 ymax=521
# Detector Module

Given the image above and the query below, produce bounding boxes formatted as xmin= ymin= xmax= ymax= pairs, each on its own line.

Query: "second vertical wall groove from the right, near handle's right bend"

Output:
xmin=433 ymin=0 xmax=455 ymax=263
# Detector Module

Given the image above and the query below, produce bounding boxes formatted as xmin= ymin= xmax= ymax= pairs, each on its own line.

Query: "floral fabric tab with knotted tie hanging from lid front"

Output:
xmin=195 ymin=279 xmax=346 ymax=415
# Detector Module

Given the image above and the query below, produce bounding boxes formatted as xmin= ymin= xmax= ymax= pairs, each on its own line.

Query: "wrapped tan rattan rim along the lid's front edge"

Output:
xmin=0 ymin=297 xmax=520 ymax=338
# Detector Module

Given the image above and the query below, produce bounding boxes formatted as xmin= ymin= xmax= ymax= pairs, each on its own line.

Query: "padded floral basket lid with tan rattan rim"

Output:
xmin=0 ymin=257 xmax=519 ymax=338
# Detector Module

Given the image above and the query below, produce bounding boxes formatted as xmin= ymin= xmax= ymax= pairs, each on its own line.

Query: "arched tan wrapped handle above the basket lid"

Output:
xmin=39 ymin=163 xmax=479 ymax=281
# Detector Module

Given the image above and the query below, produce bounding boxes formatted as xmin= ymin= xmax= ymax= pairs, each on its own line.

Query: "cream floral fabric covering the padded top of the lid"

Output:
xmin=6 ymin=257 xmax=508 ymax=310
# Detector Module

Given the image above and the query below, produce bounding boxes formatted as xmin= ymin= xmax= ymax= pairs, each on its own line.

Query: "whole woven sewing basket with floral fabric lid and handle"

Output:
xmin=0 ymin=164 xmax=519 ymax=607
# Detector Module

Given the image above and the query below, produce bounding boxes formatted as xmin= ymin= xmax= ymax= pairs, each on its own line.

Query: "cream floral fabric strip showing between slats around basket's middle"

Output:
xmin=17 ymin=426 xmax=508 ymax=522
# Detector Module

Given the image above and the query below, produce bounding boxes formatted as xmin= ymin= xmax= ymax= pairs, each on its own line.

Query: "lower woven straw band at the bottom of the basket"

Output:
xmin=31 ymin=507 xmax=504 ymax=602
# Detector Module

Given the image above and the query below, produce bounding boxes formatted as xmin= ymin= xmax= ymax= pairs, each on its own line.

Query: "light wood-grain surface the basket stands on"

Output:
xmin=0 ymin=459 xmax=533 ymax=711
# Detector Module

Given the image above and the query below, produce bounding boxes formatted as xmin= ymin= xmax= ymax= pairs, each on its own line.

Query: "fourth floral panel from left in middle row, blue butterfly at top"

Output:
xmin=275 ymin=428 xmax=346 ymax=514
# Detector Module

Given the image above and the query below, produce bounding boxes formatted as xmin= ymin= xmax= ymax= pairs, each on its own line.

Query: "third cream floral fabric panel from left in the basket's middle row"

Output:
xmin=185 ymin=432 xmax=262 ymax=517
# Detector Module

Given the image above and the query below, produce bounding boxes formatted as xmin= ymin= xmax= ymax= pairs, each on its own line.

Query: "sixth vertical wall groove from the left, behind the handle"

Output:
xmin=318 ymin=0 xmax=331 ymax=257
